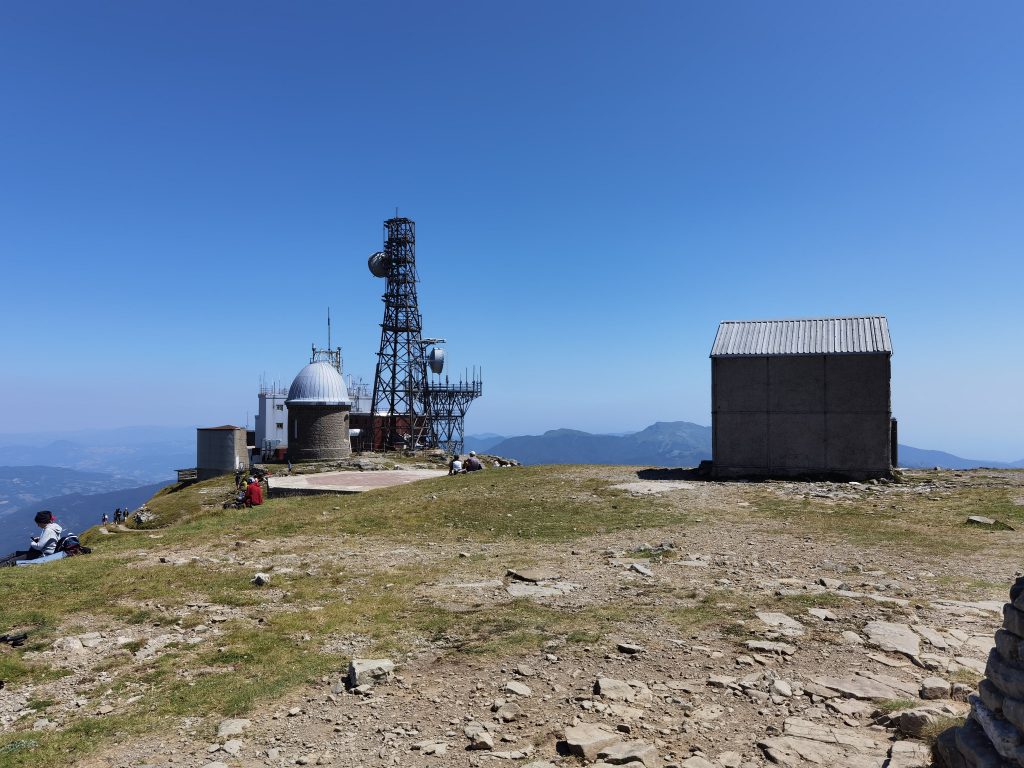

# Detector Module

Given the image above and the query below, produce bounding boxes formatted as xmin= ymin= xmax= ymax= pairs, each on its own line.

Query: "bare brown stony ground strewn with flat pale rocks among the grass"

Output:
xmin=0 ymin=473 xmax=1024 ymax=768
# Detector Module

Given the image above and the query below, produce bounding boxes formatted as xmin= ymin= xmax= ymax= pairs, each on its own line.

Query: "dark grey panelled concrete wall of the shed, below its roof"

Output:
xmin=712 ymin=354 xmax=892 ymax=478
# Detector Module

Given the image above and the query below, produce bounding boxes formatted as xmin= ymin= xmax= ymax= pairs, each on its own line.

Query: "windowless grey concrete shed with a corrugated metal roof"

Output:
xmin=711 ymin=316 xmax=895 ymax=479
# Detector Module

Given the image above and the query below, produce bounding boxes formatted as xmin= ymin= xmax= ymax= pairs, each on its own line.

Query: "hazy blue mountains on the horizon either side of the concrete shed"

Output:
xmin=465 ymin=421 xmax=1024 ymax=469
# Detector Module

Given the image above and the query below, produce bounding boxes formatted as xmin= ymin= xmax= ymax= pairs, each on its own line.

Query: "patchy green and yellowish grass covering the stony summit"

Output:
xmin=0 ymin=467 xmax=1024 ymax=768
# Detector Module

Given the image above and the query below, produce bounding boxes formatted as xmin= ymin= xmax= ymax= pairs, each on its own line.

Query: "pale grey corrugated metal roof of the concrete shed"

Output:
xmin=711 ymin=315 xmax=893 ymax=357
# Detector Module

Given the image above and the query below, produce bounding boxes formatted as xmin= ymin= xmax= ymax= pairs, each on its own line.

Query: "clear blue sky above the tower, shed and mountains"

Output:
xmin=0 ymin=0 xmax=1024 ymax=460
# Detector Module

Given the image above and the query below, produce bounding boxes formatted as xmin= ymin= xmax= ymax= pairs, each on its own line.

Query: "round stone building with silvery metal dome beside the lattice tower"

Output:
xmin=285 ymin=360 xmax=352 ymax=462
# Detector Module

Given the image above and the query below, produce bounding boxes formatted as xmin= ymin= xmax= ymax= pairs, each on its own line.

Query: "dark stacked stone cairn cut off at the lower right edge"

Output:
xmin=935 ymin=577 xmax=1024 ymax=768
